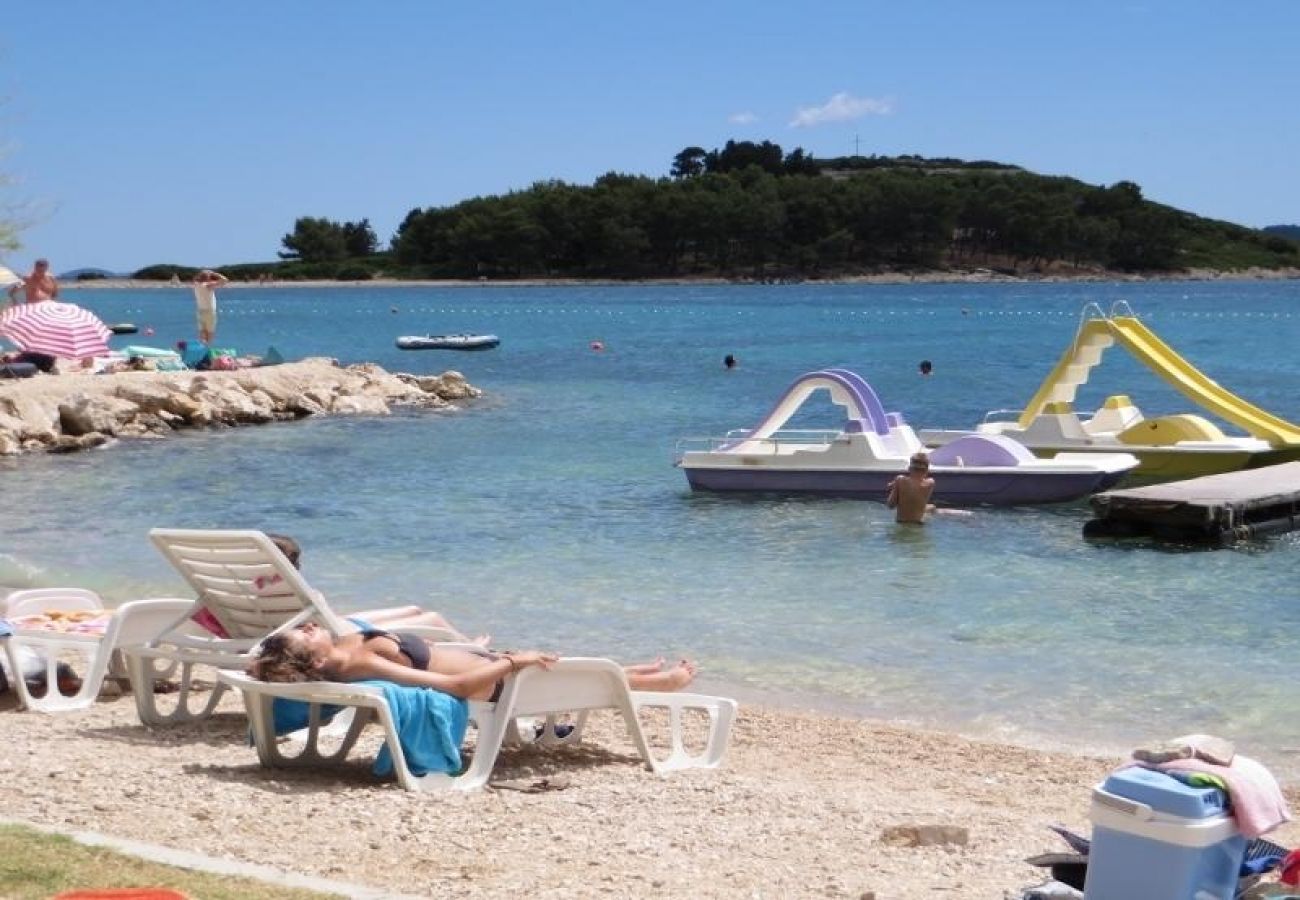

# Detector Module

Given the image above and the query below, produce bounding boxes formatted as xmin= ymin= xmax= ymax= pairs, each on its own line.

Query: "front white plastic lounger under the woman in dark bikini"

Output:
xmin=220 ymin=657 xmax=737 ymax=791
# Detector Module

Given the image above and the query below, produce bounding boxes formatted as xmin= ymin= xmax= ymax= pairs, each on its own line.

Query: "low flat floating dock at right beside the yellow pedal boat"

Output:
xmin=1083 ymin=463 xmax=1300 ymax=546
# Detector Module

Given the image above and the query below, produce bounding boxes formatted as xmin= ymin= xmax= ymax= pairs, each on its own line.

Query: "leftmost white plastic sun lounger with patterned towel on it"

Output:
xmin=0 ymin=588 xmax=192 ymax=713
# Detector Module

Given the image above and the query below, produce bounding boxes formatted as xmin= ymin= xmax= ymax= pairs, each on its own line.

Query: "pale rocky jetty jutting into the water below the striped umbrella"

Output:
xmin=0 ymin=358 xmax=482 ymax=455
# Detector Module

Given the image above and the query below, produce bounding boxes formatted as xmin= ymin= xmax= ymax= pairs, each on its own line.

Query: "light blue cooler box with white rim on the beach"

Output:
xmin=1083 ymin=767 xmax=1245 ymax=900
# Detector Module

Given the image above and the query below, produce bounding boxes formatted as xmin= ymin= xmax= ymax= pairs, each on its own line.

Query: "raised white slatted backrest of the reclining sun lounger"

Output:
xmin=150 ymin=528 xmax=343 ymax=640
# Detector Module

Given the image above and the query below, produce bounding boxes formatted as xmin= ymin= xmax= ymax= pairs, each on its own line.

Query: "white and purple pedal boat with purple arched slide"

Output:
xmin=676 ymin=368 xmax=1138 ymax=506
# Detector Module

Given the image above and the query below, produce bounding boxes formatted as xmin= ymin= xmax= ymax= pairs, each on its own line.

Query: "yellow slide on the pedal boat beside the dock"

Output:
xmin=1019 ymin=316 xmax=1300 ymax=447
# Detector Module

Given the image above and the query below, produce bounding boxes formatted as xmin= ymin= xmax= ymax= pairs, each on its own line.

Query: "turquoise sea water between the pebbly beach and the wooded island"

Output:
xmin=0 ymin=282 xmax=1300 ymax=760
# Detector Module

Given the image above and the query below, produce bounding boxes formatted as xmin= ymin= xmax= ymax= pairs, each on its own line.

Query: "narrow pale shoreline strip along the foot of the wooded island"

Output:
xmin=62 ymin=268 xmax=1300 ymax=291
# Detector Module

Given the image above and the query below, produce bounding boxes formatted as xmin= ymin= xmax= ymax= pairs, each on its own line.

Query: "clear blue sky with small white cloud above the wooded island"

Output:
xmin=0 ymin=0 xmax=1300 ymax=271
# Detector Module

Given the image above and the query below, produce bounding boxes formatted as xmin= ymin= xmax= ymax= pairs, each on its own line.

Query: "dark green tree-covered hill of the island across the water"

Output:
xmin=140 ymin=142 xmax=1300 ymax=278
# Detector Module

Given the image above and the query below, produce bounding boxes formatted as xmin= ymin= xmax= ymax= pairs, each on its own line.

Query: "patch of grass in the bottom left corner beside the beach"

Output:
xmin=0 ymin=826 xmax=337 ymax=900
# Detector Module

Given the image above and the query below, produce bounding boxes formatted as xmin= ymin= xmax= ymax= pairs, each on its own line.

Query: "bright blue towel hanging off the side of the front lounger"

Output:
xmin=360 ymin=682 xmax=469 ymax=776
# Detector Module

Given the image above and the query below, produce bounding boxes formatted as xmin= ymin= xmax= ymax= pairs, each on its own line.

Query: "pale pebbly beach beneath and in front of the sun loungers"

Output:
xmin=0 ymin=683 xmax=1300 ymax=900
